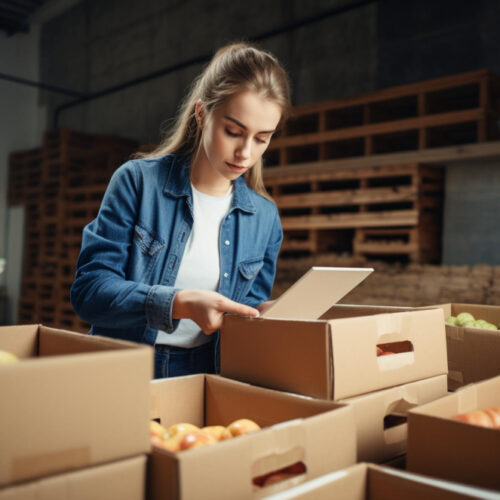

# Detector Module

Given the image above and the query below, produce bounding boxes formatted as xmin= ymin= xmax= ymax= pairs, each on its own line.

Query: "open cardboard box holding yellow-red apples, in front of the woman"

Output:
xmin=148 ymin=375 xmax=356 ymax=500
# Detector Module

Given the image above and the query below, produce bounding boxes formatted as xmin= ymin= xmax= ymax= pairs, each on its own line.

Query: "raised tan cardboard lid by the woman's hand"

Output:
xmin=262 ymin=267 xmax=373 ymax=319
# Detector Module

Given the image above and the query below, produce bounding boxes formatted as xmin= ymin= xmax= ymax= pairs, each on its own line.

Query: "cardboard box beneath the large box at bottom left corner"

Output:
xmin=0 ymin=455 xmax=146 ymax=500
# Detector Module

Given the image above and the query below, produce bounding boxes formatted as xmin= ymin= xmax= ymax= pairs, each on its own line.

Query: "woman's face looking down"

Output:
xmin=197 ymin=90 xmax=281 ymax=181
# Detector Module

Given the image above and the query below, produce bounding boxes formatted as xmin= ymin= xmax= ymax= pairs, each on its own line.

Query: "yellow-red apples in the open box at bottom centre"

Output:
xmin=149 ymin=418 xmax=260 ymax=452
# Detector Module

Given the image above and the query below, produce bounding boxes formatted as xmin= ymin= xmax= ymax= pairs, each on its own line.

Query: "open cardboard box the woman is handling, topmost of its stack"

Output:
xmin=221 ymin=302 xmax=447 ymax=399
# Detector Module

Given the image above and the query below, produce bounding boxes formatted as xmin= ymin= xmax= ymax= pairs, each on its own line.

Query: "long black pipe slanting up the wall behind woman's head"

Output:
xmin=49 ymin=0 xmax=378 ymax=129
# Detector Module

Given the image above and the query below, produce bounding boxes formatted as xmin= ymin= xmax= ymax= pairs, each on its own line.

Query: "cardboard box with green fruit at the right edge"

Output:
xmin=426 ymin=304 xmax=500 ymax=390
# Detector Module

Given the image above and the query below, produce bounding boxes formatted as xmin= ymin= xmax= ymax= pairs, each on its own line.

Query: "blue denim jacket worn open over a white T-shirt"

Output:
xmin=71 ymin=154 xmax=283 ymax=368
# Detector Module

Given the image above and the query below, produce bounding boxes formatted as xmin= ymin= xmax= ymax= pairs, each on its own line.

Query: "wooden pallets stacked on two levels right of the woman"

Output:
xmin=264 ymin=70 xmax=500 ymax=262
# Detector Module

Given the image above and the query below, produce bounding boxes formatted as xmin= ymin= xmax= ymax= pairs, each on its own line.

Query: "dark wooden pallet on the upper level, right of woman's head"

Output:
xmin=266 ymin=70 xmax=500 ymax=165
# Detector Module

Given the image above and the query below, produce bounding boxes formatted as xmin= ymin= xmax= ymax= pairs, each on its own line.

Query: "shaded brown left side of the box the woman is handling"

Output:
xmin=221 ymin=315 xmax=332 ymax=398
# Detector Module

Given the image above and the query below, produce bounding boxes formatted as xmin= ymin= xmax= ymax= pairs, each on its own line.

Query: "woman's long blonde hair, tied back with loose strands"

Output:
xmin=135 ymin=43 xmax=291 ymax=200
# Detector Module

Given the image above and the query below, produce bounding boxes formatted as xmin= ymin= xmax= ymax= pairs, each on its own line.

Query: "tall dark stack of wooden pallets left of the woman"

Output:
xmin=9 ymin=129 xmax=137 ymax=331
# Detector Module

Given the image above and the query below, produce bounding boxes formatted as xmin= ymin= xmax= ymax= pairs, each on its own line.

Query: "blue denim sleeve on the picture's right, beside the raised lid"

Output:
xmin=241 ymin=209 xmax=283 ymax=307
